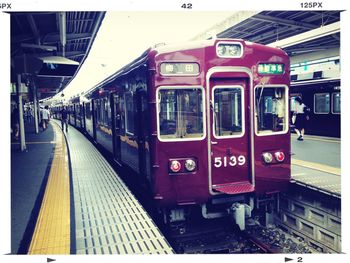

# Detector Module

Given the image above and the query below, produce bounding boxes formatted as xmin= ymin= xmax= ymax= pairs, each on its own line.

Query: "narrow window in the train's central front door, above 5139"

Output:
xmin=213 ymin=87 xmax=244 ymax=137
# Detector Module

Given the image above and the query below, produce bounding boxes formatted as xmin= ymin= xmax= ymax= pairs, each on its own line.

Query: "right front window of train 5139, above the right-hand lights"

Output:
xmin=255 ymin=86 xmax=288 ymax=135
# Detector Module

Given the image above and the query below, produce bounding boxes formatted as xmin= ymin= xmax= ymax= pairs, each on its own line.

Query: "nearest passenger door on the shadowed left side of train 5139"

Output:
xmin=111 ymin=93 xmax=124 ymax=161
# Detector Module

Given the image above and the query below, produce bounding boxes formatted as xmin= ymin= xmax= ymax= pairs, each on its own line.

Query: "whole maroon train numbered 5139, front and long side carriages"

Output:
xmin=64 ymin=39 xmax=291 ymax=229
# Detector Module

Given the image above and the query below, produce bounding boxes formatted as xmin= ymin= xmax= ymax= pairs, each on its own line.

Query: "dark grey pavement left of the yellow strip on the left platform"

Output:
xmin=11 ymin=122 xmax=55 ymax=254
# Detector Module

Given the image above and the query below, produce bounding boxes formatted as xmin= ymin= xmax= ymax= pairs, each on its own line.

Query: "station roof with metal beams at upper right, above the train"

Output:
xmin=194 ymin=11 xmax=340 ymax=56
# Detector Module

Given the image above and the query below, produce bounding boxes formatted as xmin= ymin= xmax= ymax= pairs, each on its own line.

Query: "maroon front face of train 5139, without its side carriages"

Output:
xmin=150 ymin=39 xmax=291 ymax=225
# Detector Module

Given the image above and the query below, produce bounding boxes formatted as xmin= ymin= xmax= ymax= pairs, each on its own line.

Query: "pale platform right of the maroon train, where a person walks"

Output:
xmin=291 ymin=134 xmax=341 ymax=198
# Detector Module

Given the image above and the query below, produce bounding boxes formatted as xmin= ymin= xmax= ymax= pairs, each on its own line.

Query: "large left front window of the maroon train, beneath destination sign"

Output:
xmin=158 ymin=88 xmax=204 ymax=140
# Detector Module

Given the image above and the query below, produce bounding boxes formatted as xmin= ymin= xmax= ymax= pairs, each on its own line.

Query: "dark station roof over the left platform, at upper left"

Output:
xmin=10 ymin=12 xmax=105 ymax=99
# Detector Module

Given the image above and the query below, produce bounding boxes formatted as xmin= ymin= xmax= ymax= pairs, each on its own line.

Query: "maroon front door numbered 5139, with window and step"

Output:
xmin=208 ymin=77 xmax=254 ymax=194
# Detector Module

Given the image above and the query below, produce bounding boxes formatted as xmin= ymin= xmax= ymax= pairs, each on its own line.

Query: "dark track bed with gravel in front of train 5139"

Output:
xmin=166 ymin=218 xmax=314 ymax=254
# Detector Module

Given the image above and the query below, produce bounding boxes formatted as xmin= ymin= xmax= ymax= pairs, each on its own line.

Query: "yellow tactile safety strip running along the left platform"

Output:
xmin=28 ymin=124 xmax=70 ymax=254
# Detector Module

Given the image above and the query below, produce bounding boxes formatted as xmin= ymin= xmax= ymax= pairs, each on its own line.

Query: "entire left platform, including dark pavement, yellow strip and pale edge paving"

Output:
xmin=11 ymin=120 xmax=174 ymax=255
